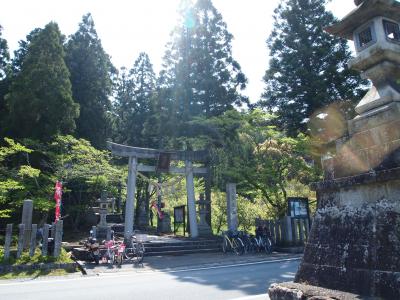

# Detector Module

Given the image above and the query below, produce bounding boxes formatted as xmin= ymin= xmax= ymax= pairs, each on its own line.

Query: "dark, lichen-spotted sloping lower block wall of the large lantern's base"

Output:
xmin=295 ymin=170 xmax=400 ymax=299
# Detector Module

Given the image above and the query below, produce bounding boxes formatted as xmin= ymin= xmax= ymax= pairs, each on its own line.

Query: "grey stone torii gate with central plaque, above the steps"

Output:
xmin=107 ymin=142 xmax=208 ymax=238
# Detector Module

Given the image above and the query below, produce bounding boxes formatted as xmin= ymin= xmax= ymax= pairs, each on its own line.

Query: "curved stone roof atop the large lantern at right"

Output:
xmin=325 ymin=0 xmax=400 ymax=40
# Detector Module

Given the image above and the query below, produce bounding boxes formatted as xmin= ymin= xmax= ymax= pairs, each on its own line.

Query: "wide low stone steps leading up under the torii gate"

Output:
xmin=144 ymin=237 xmax=221 ymax=256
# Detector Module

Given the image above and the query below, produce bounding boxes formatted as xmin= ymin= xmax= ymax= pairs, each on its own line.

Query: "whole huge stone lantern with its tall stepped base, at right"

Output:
xmin=269 ymin=0 xmax=400 ymax=299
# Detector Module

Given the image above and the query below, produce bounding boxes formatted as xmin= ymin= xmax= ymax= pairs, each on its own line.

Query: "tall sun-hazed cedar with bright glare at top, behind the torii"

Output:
xmin=161 ymin=0 xmax=248 ymax=144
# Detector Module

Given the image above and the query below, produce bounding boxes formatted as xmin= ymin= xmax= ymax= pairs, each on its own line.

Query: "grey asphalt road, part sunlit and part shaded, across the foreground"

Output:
xmin=0 ymin=260 xmax=300 ymax=300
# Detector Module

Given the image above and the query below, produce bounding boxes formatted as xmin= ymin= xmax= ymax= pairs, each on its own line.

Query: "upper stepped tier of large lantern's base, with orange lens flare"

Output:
xmin=323 ymin=103 xmax=400 ymax=179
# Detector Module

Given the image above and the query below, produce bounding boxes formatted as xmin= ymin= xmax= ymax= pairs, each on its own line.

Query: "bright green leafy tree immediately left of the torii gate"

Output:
xmin=46 ymin=136 xmax=125 ymax=229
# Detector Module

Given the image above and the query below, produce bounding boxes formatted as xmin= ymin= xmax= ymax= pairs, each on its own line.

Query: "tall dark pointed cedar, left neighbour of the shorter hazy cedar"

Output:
xmin=66 ymin=14 xmax=115 ymax=148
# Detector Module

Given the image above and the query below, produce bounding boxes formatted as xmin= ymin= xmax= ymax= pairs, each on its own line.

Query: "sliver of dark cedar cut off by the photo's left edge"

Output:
xmin=0 ymin=25 xmax=10 ymax=137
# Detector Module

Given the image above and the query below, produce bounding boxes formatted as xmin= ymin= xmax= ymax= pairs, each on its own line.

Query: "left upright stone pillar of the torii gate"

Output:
xmin=124 ymin=156 xmax=137 ymax=238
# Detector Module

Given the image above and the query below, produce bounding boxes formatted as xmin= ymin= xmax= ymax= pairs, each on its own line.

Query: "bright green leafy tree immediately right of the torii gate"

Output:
xmin=198 ymin=110 xmax=317 ymax=216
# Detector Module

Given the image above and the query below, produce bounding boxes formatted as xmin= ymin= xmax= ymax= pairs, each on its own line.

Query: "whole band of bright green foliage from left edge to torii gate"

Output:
xmin=0 ymin=136 xmax=126 ymax=229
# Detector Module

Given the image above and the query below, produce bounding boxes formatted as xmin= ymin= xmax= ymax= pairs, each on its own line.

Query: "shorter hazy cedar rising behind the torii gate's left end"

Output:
xmin=114 ymin=53 xmax=156 ymax=147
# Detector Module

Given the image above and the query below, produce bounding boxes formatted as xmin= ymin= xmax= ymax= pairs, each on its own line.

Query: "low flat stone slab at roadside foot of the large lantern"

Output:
xmin=268 ymin=282 xmax=365 ymax=300
